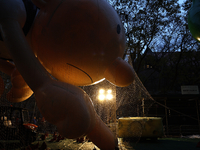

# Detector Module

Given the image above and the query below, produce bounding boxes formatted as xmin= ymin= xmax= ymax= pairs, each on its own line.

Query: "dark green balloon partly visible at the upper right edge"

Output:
xmin=188 ymin=0 xmax=200 ymax=42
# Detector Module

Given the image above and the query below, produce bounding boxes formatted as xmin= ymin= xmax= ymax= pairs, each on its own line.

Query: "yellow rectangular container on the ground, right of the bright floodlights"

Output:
xmin=118 ymin=117 xmax=164 ymax=138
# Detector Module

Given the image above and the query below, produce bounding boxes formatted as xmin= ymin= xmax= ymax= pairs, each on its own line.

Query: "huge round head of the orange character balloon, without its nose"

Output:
xmin=32 ymin=0 xmax=127 ymax=85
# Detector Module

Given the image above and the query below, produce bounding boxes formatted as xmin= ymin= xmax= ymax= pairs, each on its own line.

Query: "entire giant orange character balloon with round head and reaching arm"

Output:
xmin=0 ymin=0 xmax=134 ymax=150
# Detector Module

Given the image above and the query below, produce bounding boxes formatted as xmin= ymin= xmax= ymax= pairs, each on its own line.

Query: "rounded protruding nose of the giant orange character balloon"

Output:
xmin=104 ymin=57 xmax=135 ymax=87
